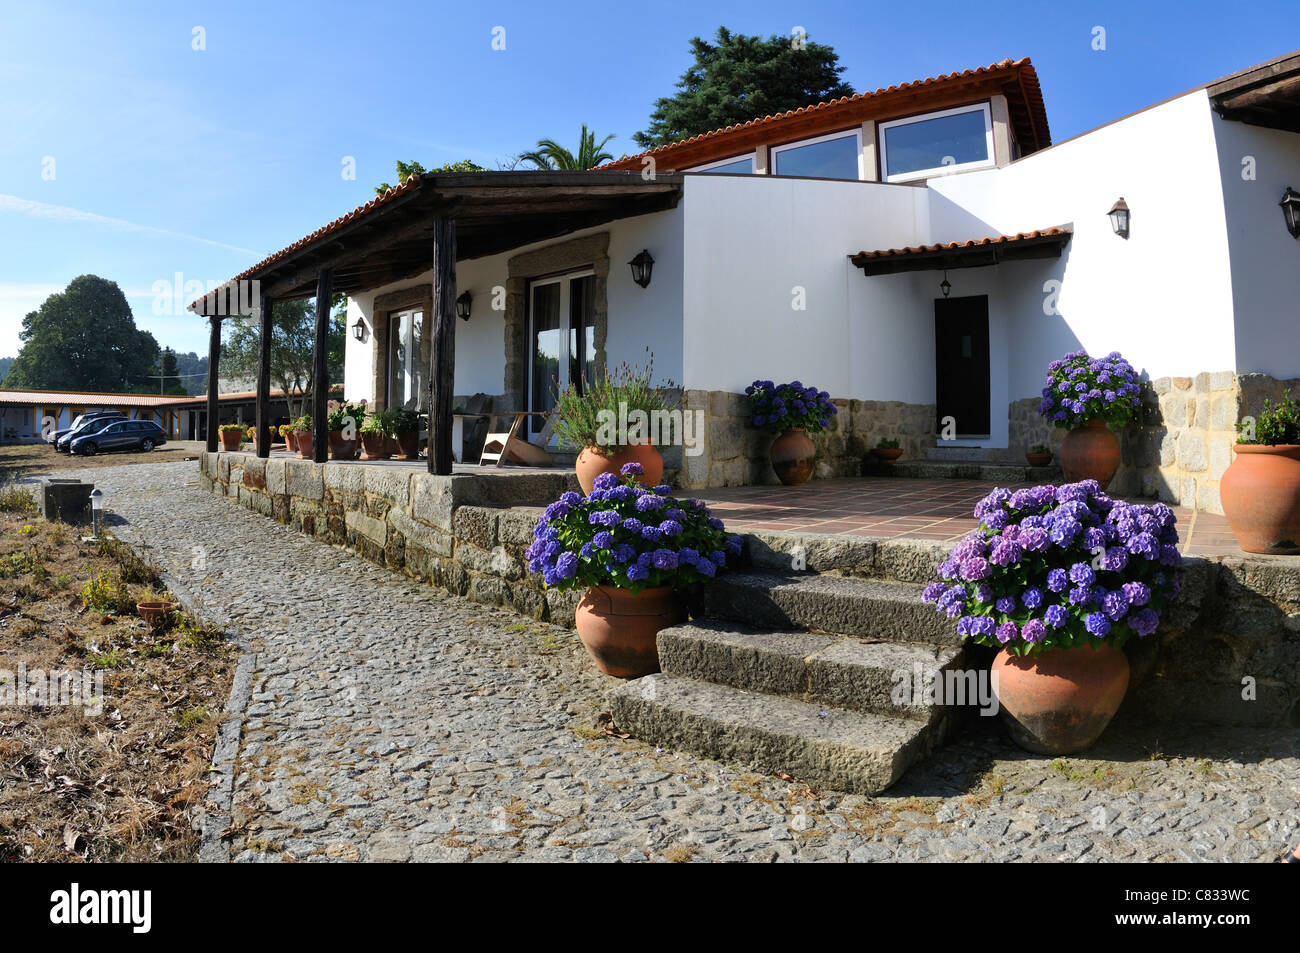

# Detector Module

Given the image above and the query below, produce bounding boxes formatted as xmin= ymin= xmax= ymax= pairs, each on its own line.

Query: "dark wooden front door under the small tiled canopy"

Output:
xmin=935 ymin=295 xmax=989 ymax=437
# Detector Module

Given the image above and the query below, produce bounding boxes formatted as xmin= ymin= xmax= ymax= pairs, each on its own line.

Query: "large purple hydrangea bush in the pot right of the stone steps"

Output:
xmin=923 ymin=480 xmax=1182 ymax=654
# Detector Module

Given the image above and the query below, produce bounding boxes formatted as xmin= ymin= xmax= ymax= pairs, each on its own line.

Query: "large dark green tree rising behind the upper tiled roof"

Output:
xmin=632 ymin=26 xmax=853 ymax=150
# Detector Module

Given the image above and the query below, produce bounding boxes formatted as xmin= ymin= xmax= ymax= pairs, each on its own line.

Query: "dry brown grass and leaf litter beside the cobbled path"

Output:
xmin=0 ymin=499 xmax=235 ymax=862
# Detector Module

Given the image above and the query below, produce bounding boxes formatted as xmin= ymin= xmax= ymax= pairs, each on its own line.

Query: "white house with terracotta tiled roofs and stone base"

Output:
xmin=191 ymin=55 xmax=1300 ymax=511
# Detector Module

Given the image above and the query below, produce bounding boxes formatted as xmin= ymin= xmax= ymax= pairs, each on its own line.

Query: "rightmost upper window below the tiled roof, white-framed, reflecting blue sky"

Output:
xmin=880 ymin=103 xmax=993 ymax=182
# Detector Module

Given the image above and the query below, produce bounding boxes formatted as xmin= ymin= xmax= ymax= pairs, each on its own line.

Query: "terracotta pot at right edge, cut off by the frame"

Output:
xmin=1219 ymin=443 xmax=1300 ymax=556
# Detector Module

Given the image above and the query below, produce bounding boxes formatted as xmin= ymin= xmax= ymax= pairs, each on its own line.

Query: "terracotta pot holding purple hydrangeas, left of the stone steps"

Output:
xmin=575 ymin=585 xmax=686 ymax=679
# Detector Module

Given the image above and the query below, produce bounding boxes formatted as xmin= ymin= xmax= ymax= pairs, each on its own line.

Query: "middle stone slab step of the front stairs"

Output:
xmin=659 ymin=621 xmax=963 ymax=723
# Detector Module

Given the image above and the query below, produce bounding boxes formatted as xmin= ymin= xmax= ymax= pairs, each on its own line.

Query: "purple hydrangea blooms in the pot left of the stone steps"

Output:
xmin=524 ymin=463 xmax=741 ymax=592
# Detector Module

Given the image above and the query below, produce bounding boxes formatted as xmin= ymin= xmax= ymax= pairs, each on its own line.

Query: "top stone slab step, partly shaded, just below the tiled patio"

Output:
xmin=694 ymin=572 xmax=961 ymax=645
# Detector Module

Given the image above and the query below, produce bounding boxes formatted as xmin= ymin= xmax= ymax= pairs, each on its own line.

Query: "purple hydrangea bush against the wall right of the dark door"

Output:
xmin=1039 ymin=351 xmax=1141 ymax=430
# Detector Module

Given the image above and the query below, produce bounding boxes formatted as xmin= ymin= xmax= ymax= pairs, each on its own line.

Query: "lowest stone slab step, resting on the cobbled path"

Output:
xmin=610 ymin=673 xmax=931 ymax=794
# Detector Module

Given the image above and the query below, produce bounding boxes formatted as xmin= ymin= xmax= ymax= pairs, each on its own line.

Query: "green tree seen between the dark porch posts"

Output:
xmin=221 ymin=295 xmax=347 ymax=417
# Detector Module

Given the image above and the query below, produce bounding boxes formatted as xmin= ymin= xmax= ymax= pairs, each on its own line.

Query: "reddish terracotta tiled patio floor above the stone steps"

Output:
xmin=699 ymin=477 xmax=1268 ymax=562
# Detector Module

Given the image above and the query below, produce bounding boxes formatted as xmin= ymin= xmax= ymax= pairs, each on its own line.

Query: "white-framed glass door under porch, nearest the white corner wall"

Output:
xmin=528 ymin=272 xmax=597 ymax=434
